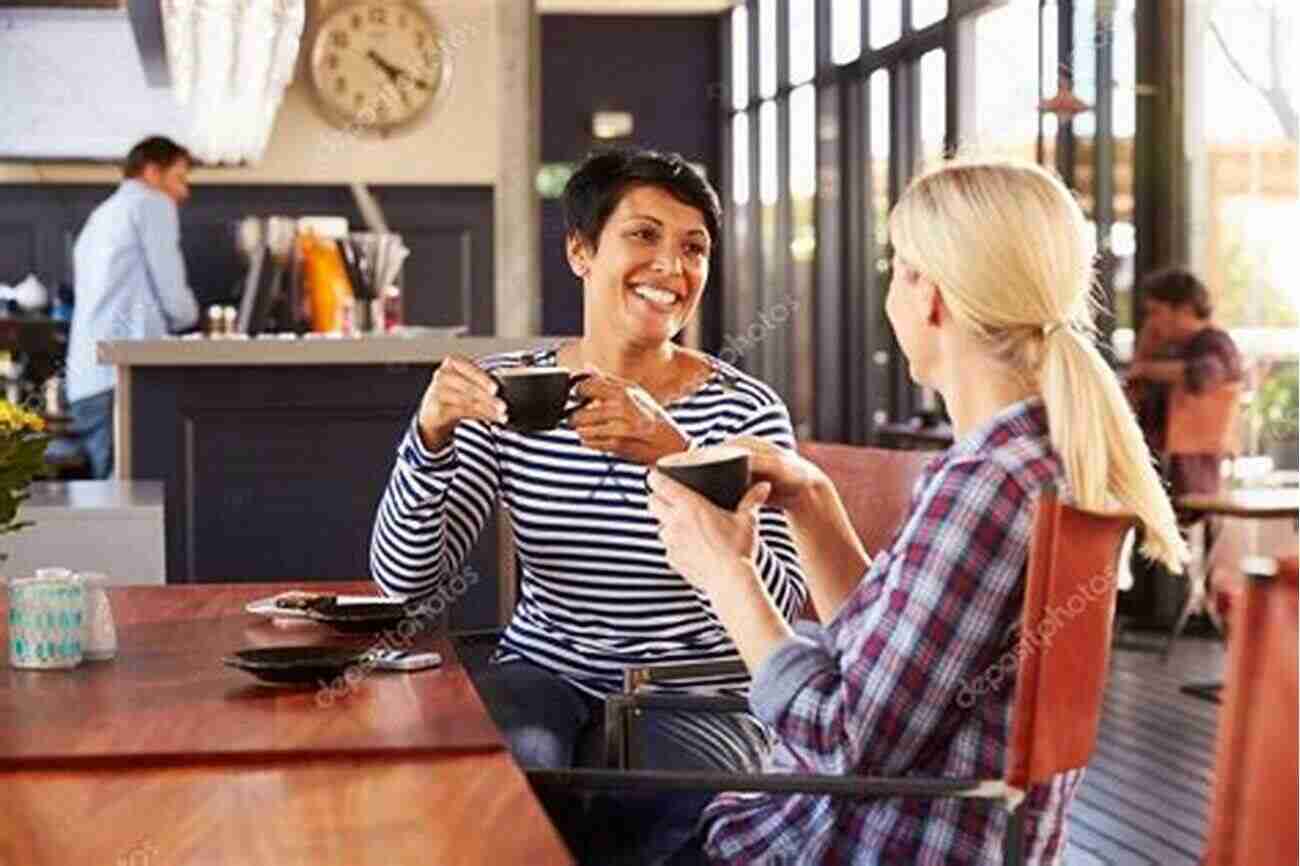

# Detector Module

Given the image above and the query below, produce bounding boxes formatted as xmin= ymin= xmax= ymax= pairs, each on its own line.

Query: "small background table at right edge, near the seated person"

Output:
xmin=1169 ymin=488 xmax=1300 ymax=703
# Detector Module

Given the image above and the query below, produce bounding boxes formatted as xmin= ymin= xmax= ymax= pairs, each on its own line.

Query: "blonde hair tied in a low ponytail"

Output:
xmin=889 ymin=160 xmax=1188 ymax=571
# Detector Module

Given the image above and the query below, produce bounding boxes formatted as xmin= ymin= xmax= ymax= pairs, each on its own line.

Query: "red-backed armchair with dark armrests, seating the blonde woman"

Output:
xmin=528 ymin=489 xmax=1133 ymax=865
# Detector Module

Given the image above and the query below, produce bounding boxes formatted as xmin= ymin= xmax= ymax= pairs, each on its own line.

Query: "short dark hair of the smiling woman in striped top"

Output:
xmin=564 ymin=148 xmax=723 ymax=250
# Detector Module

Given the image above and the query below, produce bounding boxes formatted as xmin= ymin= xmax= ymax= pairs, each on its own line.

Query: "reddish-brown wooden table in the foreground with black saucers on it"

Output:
xmin=0 ymin=584 xmax=572 ymax=866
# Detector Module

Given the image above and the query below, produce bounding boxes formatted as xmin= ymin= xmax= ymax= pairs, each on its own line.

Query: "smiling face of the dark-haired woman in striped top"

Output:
xmin=568 ymin=185 xmax=712 ymax=346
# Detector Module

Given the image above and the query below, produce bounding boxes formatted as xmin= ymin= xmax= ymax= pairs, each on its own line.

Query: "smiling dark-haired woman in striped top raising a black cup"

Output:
xmin=371 ymin=151 xmax=807 ymax=866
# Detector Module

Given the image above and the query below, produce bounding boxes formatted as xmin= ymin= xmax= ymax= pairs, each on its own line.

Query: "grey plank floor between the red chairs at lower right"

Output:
xmin=1065 ymin=638 xmax=1225 ymax=866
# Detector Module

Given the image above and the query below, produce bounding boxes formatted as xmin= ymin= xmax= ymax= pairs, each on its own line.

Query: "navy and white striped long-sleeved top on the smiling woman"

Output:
xmin=371 ymin=347 xmax=807 ymax=696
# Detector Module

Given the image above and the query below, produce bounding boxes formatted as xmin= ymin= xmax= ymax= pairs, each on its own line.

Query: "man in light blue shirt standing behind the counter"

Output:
xmin=68 ymin=137 xmax=199 ymax=479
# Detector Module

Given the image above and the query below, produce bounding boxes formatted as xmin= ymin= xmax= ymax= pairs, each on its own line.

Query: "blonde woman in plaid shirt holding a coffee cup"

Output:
xmin=651 ymin=161 xmax=1184 ymax=866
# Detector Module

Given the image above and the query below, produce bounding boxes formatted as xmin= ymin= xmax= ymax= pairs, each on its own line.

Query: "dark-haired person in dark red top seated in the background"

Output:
xmin=1127 ymin=268 xmax=1243 ymax=497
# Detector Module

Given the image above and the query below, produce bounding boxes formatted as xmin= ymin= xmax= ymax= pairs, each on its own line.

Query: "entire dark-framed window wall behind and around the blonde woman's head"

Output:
xmin=723 ymin=0 xmax=1159 ymax=442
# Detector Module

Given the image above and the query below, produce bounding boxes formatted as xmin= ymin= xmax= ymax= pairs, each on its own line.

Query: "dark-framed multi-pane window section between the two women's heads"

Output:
xmin=724 ymin=0 xmax=953 ymax=441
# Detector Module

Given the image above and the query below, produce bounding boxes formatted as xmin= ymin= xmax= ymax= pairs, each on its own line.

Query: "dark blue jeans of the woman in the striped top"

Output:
xmin=473 ymin=662 xmax=767 ymax=866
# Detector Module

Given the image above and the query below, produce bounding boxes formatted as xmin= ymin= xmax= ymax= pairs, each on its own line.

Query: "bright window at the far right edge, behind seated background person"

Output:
xmin=1184 ymin=0 xmax=1300 ymax=468
